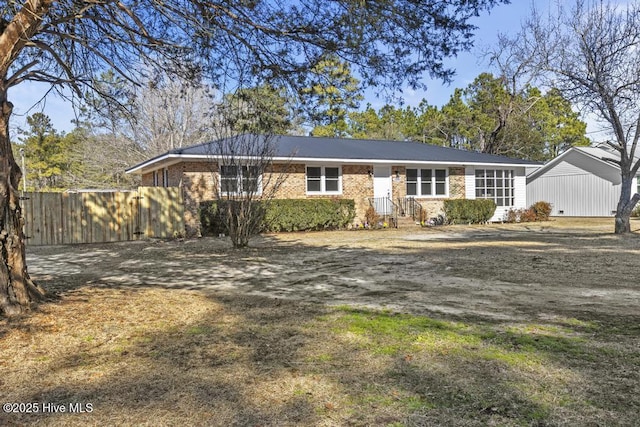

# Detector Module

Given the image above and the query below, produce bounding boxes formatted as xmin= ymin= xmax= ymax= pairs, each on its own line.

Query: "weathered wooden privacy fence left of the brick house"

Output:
xmin=22 ymin=187 xmax=184 ymax=245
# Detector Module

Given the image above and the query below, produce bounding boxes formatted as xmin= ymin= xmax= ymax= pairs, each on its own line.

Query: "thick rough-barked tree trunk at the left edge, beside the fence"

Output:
xmin=0 ymin=97 xmax=45 ymax=316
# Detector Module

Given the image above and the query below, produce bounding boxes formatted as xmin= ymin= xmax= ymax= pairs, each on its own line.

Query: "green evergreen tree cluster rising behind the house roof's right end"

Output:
xmin=441 ymin=73 xmax=589 ymax=161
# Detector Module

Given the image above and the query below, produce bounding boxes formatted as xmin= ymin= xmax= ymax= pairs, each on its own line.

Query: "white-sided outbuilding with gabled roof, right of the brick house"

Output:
xmin=527 ymin=147 xmax=638 ymax=217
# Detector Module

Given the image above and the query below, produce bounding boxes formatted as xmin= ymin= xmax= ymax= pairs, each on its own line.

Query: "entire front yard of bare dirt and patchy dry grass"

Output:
xmin=0 ymin=219 xmax=640 ymax=426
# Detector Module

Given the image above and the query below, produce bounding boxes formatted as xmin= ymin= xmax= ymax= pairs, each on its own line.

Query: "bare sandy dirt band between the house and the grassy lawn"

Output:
xmin=28 ymin=219 xmax=640 ymax=320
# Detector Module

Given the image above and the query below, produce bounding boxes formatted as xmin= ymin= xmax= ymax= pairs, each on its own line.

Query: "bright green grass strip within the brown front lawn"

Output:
xmin=334 ymin=308 xmax=589 ymax=366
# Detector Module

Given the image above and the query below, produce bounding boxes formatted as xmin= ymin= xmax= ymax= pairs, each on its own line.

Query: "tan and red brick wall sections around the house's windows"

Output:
xmin=142 ymin=162 xmax=465 ymax=236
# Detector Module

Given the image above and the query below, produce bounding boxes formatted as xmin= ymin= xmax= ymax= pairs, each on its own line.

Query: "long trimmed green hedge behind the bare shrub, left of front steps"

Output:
xmin=200 ymin=199 xmax=356 ymax=235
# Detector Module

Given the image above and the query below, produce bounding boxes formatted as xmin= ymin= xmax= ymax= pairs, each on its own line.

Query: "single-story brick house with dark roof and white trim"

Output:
xmin=127 ymin=135 xmax=540 ymax=233
